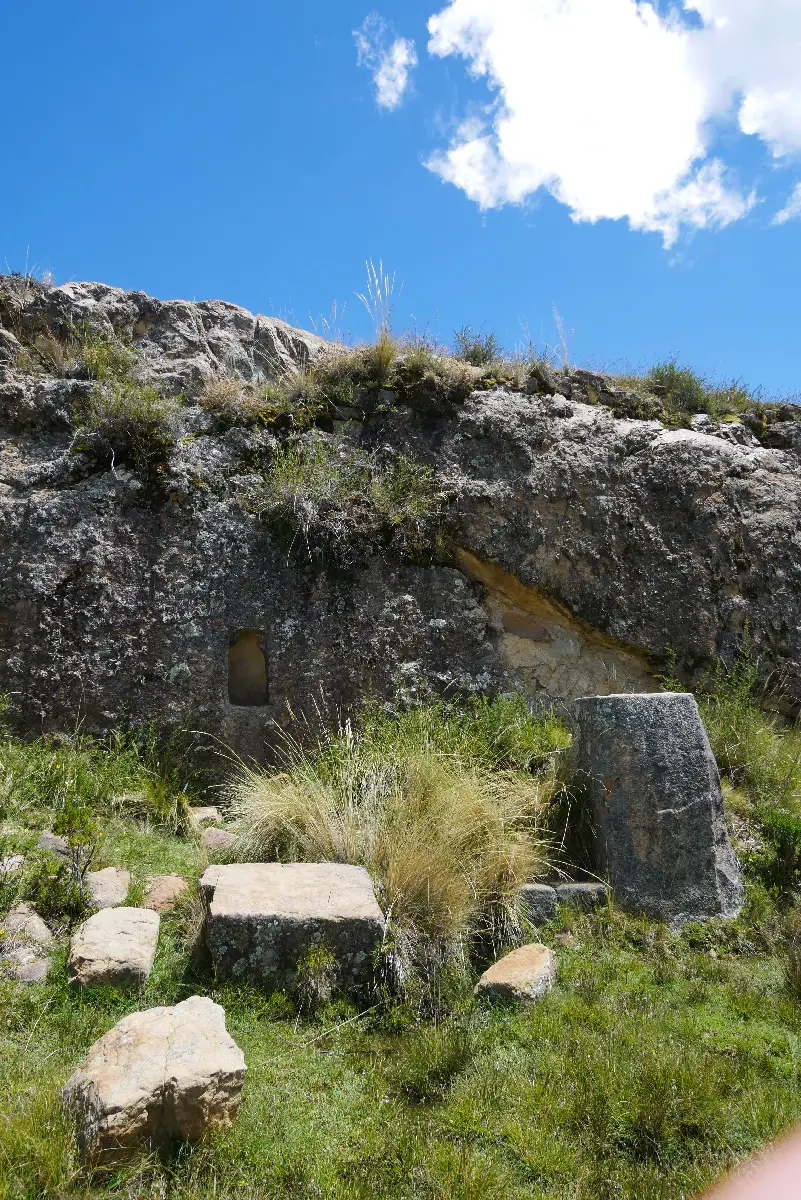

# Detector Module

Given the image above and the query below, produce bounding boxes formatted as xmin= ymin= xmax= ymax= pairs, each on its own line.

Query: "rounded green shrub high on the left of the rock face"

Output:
xmin=73 ymin=379 xmax=177 ymax=478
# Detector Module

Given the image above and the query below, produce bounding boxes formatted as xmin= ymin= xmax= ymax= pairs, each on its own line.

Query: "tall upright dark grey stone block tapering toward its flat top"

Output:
xmin=572 ymin=692 xmax=742 ymax=922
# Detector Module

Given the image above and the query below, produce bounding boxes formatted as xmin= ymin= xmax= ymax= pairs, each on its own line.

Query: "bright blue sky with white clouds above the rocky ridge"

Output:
xmin=0 ymin=0 xmax=801 ymax=394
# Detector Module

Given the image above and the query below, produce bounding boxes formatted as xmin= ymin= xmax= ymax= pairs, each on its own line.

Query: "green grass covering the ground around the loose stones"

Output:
xmin=0 ymin=679 xmax=801 ymax=1200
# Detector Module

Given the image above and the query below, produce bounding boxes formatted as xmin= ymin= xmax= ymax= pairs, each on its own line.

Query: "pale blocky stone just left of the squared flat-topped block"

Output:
xmin=67 ymin=908 xmax=159 ymax=988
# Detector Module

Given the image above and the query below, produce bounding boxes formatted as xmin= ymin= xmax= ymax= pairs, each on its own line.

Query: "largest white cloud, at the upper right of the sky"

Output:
xmin=428 ymin=0 xmax=801 ymax=245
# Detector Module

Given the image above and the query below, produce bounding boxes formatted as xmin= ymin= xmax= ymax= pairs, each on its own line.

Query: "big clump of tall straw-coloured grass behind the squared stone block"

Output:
xmin=221 ymin=702 xmax=565 ymax=986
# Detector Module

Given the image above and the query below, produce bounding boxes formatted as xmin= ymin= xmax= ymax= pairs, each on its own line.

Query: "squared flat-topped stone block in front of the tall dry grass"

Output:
xmin=200 ymin=863 xmax=385 ymax=990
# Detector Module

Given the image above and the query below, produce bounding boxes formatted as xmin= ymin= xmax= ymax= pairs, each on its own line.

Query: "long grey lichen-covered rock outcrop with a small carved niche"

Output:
xmin=0 ymin=276 xmax=801 ymax=754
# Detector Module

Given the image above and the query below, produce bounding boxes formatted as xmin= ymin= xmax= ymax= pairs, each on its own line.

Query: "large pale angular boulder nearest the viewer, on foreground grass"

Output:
xmin=61 ymin=996 xmax=247 ymax=1163
